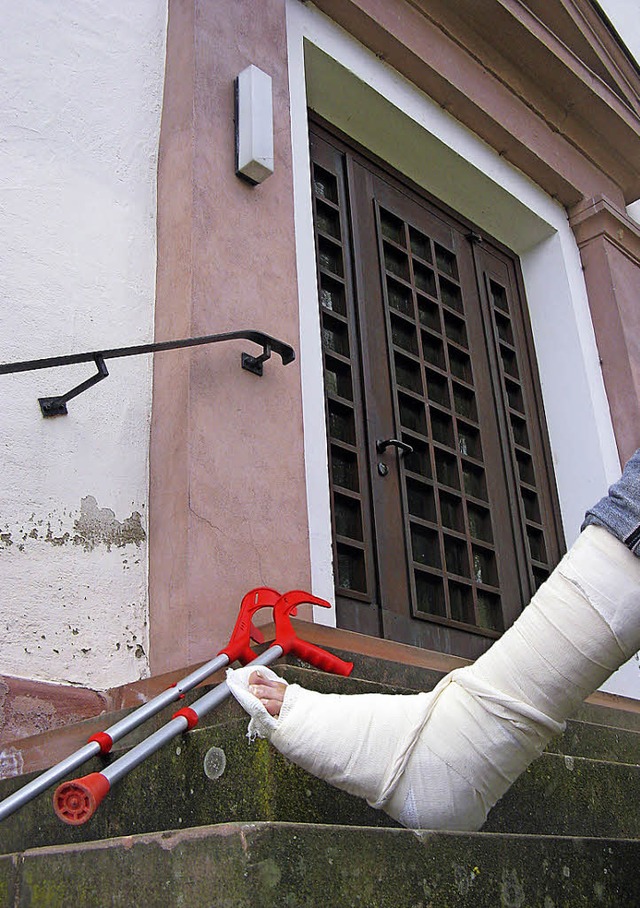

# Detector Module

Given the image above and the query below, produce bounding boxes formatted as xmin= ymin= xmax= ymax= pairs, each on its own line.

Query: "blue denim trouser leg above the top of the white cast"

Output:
xmin=582 ymin=449 xmax=640 ymax=557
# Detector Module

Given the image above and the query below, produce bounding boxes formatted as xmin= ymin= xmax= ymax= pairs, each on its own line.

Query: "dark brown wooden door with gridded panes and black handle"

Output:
xmin=311 ymin=126 xmax=562 ymax=657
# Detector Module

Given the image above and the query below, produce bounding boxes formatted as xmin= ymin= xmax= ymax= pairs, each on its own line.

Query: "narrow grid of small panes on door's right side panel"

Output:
xmin=488 ymin=278 xmax=551 ymax=589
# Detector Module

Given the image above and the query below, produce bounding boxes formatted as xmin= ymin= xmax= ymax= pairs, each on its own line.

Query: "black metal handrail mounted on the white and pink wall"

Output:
xmin=0 ymin=330 xmax=296 ymax=416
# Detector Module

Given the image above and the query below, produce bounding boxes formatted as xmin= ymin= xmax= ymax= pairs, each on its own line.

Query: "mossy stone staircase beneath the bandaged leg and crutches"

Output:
xmin=0 ymin=625 xmax=640 ymax=908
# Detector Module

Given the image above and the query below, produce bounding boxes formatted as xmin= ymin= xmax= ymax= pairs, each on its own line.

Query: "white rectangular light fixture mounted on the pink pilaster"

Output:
xmin=236 ymin=64 xmax=273 ymax=185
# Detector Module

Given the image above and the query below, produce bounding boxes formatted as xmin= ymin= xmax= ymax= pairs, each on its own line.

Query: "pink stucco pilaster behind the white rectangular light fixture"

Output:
xmin=150 ymin=0 xmax=310 ymax=673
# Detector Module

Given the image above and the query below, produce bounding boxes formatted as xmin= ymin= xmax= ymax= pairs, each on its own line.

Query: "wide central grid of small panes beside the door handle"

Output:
xmin=378 ymin=208 xmax=503 ymax=632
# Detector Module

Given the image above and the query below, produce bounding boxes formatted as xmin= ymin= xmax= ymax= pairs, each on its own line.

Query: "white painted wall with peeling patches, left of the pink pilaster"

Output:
xmin=0 ymin=0 xmax=167 ymax=687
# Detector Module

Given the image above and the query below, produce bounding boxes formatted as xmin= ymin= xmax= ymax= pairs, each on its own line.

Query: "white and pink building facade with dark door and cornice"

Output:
xmin=0 ymin=0 xmax=640 ymax=744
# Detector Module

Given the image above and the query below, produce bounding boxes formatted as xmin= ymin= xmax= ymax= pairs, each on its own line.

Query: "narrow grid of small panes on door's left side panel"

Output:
xmin=313 ymin=163 xmax=371 ymax=597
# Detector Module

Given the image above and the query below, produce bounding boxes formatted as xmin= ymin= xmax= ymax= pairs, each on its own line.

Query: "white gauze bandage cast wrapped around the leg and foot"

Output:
xmin=228 ymin=526 xmax=640 ymax=830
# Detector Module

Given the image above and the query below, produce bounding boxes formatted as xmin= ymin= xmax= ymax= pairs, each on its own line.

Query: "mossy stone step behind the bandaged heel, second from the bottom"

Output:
xmin=0 ymin=717 xmax=640 ymax=853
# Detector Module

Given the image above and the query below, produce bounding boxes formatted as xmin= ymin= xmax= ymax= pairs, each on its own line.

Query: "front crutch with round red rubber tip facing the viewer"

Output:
xmin=53 ymin=590 xmax=353 ymax=826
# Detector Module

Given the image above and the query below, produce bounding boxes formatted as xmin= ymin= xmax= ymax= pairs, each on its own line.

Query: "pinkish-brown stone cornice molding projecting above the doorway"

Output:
xmin=315 ymin=0 xmax=640 ymax=208
